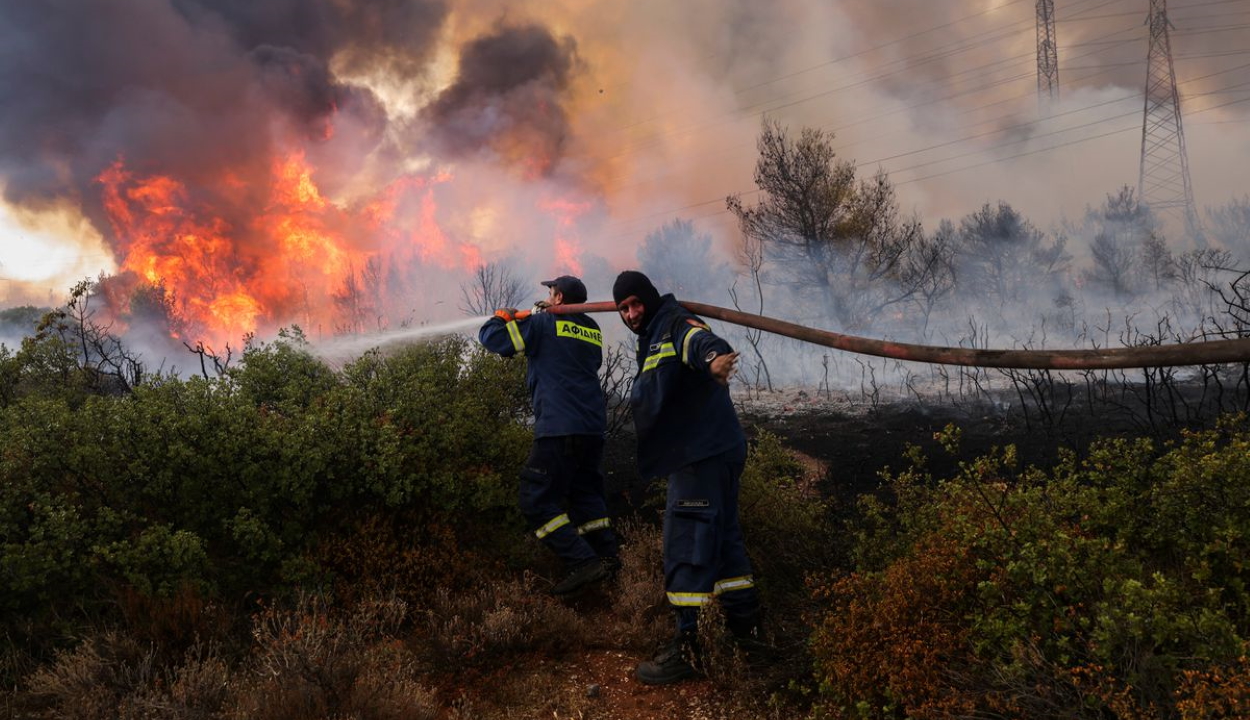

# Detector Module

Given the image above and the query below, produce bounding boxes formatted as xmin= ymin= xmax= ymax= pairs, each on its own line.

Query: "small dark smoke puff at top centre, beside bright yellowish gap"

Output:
xmin=423 ymin=25 xmax=579 ymax=175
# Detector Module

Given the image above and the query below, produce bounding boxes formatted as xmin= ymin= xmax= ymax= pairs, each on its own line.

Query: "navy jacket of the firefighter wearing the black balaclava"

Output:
xmin=630 ymin=294 xmax=746 ymax=479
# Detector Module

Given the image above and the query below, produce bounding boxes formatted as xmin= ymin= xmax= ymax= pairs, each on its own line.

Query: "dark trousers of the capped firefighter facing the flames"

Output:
xmin=520 ymin=435 xmax=618 ymax=568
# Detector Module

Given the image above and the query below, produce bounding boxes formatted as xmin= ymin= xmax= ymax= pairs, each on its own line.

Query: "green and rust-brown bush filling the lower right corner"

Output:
xmin=814 ymin=419 xmax=1250 ymax=718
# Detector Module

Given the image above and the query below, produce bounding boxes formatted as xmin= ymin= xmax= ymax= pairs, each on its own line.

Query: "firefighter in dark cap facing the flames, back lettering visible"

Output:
xmin=478 ymin=275 xmax=620 ymax=595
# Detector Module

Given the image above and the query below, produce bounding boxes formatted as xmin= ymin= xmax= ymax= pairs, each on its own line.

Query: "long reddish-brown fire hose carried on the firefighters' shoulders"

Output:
xmin=545 ymin=301 xmax=1250 ymax=370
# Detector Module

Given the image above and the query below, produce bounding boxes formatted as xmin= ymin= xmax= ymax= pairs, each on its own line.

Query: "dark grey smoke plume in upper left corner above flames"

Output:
xmin=0 ymin=0 xmax=446 ymax=226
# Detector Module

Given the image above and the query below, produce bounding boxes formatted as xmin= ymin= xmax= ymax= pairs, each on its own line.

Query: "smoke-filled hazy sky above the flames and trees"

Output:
xmin=0 ymin=0 xmax=1250 ymax=310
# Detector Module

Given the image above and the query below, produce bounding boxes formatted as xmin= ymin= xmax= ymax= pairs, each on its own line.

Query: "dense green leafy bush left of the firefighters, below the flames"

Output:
xmin=0 ymin=334 xmax=530 ymax=650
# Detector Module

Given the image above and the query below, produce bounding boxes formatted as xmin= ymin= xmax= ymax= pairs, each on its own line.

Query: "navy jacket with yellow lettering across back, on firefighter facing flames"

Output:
xmin=478 ymin=313 xmax=608 ymax=438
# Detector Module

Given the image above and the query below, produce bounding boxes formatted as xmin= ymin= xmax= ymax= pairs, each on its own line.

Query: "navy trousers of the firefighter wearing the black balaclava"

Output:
xmin=664 ymin=445 xmax=760 ymax=633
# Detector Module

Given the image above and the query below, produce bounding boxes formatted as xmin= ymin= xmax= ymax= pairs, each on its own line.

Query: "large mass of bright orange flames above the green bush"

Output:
xmin=98 ymin=151 xmax=481 ymax=349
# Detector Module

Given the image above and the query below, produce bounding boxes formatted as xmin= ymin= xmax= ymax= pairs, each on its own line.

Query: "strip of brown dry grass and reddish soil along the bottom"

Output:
xmin=20 ymin=523 xmax=805 ymax=720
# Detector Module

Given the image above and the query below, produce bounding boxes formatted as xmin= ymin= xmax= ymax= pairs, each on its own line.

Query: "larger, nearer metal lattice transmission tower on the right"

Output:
xmin=1138 ymin=0 xmax=1199 ymax=238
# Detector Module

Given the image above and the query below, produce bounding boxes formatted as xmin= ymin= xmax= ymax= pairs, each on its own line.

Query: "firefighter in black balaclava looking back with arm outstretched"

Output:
xmin=613 ymin=270 xmax=764 ymax=685
